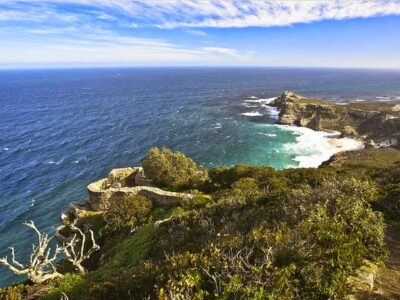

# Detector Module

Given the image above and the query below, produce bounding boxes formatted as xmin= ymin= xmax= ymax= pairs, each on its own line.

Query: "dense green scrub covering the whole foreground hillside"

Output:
xmin=0 ymin=148 xmax=400 ymax=299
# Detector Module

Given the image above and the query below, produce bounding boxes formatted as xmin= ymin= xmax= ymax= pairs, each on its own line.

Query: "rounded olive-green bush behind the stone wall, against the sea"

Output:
xmin=142 ymin=148 xmax=208 ymax=190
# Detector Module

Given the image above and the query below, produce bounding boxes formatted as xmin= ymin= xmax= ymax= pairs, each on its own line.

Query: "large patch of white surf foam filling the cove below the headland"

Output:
xmin=279 ymin=125 xmax=364 ymax=168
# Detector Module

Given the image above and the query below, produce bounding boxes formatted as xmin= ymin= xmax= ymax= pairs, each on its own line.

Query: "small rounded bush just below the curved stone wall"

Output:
xmin=104 ymin=194 xmax=153 ymax=230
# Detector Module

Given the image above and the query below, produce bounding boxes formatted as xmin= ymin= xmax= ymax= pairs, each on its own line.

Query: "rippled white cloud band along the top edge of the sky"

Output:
xmin=0 ymin=0 xmax=400 ymax=28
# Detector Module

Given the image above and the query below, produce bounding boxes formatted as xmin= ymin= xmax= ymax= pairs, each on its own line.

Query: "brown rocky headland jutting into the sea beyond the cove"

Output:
xmin=272 ymin=91 xmax=400 ymax=147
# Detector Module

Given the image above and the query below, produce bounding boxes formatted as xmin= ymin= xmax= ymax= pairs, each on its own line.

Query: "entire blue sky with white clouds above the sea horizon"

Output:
xmin=0 ymin=0 xmax=400 ymax=69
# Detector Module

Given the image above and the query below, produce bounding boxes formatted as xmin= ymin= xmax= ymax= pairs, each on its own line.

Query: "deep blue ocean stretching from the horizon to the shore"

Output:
xmin=0 ymin=68 xmax=400 ymax=286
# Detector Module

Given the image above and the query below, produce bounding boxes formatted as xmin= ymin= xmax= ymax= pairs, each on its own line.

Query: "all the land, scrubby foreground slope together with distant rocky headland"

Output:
xmin=0 ymin=92 xmax=400 ymax=300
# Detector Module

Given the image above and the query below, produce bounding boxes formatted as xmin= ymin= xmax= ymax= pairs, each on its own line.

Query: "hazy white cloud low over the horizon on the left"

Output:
xmin=0 ymin=26 xmax=245 ymax=67
